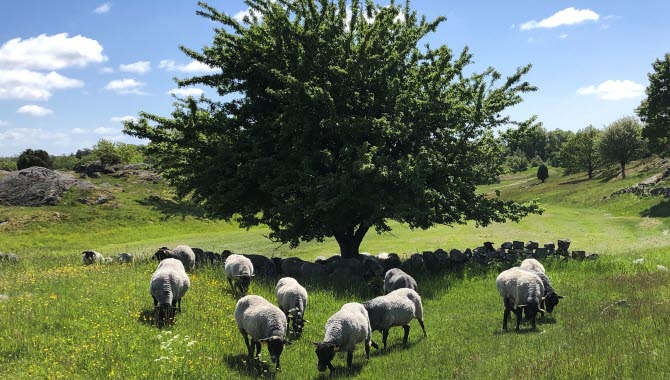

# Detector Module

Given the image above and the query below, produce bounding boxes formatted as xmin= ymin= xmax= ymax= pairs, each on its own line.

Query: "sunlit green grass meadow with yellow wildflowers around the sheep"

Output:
xmin=0 ymin=162 xmax=670 ymax=379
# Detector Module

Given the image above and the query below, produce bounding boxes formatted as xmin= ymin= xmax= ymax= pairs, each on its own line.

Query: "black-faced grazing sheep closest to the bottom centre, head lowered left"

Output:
xmin=313 ymin=302 xmax=378 ymax=372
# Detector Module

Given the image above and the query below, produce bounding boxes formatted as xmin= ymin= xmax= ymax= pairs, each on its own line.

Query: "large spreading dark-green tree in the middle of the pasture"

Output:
xmin=125 ymin=0 xmax=541 ymax=257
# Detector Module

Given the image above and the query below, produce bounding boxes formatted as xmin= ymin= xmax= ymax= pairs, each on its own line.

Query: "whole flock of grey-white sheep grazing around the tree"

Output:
xmin=83 ymin=245 xmax=563 ymax=372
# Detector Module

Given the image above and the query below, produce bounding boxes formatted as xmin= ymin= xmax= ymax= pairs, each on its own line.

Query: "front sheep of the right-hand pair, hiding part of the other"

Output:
xmin=496 ymin=267 xmax=544 ymax=331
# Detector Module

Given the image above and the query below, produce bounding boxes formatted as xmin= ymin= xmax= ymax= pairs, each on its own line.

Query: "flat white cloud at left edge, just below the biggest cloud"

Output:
xmin=0 ymin=69 xmax=84 ymax=100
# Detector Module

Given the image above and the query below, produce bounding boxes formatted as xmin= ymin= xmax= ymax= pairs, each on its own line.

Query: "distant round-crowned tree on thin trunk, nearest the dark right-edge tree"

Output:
xmin=598 ymin=116 xmax=643 ymax=178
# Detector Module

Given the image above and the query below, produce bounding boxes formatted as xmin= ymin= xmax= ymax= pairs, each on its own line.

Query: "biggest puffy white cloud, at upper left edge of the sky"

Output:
xmin=0 ymin=33 xmax=107 ymax=70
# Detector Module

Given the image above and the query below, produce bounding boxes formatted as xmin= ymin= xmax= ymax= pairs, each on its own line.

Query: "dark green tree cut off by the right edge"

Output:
xmin=637 ymin=53 xmax=670 ymax=156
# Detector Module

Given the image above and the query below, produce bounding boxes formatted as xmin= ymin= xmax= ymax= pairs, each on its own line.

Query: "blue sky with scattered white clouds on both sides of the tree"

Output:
xmin=0 ymin=0 xmax=670 ymax=157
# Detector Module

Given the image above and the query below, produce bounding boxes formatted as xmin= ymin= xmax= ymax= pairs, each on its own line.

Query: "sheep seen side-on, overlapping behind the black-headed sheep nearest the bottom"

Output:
xmin=363 ymin=288 xmax=428 ymax=349
